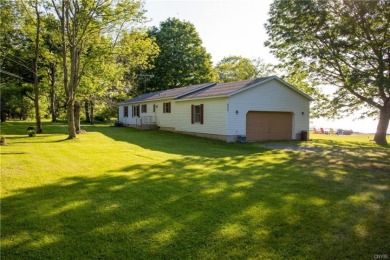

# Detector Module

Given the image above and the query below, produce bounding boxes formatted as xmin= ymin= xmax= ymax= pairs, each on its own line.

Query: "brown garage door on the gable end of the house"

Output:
xmin=246 ymin=111 xmax=292 ymax=141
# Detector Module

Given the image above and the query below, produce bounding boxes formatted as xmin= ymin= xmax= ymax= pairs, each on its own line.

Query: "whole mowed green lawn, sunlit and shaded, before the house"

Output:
xmin=1 ymin=122 xmax=390 ymax=259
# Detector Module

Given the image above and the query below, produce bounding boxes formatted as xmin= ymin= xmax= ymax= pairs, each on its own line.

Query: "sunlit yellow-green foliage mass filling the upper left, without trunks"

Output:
xmin=0 ymin=0 xmax=158 ymax=129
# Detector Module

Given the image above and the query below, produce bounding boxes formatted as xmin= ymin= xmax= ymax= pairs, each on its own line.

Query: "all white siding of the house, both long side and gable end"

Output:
xmin=119 ymin=80 xmax=309 ymax=141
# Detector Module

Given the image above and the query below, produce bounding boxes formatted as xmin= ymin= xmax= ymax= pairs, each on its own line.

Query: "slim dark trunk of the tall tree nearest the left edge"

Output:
xmin=33 ymin=2 xmax=43 ymax=134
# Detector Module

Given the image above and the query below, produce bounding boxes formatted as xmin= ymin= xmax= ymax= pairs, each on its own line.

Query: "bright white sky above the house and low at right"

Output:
xmin=145 ymin=0 xmax=384 ymax=133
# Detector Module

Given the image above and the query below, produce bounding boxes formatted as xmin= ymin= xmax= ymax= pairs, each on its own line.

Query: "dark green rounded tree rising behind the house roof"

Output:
xmin=143 ymin=18 xmax=214 ymax=92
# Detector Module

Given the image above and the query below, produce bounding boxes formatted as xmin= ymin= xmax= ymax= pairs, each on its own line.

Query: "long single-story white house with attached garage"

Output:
xmin=119 ymin=76 xmax=312 ymax=142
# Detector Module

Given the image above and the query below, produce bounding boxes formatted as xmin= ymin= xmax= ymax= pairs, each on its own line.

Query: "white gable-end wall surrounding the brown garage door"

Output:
xmin=228 ymin=80 xmax=309 ymax=139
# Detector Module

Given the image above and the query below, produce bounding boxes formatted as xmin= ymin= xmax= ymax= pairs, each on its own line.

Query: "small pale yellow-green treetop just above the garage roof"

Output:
xmin=214 ymin=56 xmax=274 ymax=82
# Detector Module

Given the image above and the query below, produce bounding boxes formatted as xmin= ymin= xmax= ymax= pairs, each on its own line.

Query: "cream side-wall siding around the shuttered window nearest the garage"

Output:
xmin=175 ymin=98 xmax=227 ymax=135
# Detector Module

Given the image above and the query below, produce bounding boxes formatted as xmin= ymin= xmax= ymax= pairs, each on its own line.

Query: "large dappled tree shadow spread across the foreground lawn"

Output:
xmin=1 ymin=150 xmax=390 ymax=259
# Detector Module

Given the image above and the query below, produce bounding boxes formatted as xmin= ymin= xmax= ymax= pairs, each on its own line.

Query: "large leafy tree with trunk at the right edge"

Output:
xmin=266 ymin=0 xmax=390 ymax=144
